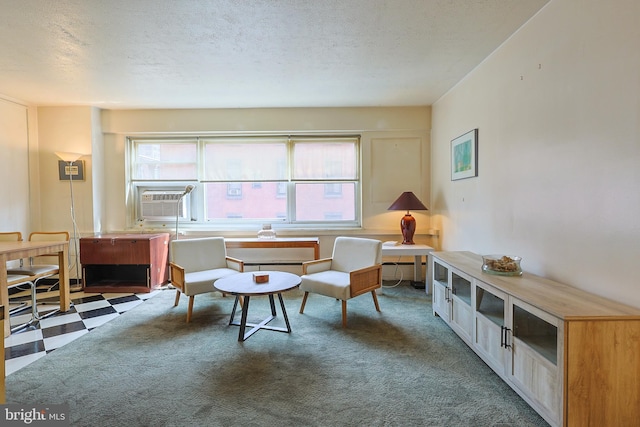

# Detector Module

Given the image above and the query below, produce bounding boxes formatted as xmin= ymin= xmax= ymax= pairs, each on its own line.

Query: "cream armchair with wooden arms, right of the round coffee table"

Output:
xmin=300 ymin=237 xmax=382 ymax=327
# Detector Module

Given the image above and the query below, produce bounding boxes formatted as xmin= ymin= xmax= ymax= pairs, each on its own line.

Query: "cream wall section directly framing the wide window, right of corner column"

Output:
xmin=101 ymin=107 xmax=431 ymax=246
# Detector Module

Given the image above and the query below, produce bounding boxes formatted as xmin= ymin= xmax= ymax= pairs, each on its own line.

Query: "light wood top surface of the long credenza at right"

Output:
xmin=431 ymin=252 xmax=640 ymax=320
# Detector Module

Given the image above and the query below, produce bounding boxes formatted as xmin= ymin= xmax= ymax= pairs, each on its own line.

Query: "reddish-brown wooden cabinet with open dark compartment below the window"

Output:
xmin=80 ymin=233 xmax=169 ymax=293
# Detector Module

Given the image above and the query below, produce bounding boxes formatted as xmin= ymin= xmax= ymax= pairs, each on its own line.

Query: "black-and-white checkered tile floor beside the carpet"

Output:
xmin=4 ymin=290 xmax=159 ymax=375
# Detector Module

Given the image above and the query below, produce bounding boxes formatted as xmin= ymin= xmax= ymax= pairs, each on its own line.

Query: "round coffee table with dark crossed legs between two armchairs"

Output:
xmin=213 ymin=271 xmax=300 ymax=341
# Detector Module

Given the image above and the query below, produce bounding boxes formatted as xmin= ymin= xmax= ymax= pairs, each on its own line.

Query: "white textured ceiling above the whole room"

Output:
xmin=0 ymin=0 xmax=548 ymax=109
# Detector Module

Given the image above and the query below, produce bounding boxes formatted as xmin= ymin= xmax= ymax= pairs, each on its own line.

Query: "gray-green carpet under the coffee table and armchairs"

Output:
xmin=6 ymin=285 xmax=547 ymax=427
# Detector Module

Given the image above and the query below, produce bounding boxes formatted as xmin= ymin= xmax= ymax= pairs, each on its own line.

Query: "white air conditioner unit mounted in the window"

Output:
xmin=140 ymin=190 xmax=191 ymax=220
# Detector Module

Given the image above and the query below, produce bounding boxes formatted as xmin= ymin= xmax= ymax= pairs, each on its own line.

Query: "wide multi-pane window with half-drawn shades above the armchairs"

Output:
xmin=128 ymin=136 xmax=360 ymax=227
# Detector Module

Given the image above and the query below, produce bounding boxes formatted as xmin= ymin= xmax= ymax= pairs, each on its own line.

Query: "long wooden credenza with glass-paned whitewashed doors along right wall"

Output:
xmin=432 ymin=252 xmax=640 ymax=427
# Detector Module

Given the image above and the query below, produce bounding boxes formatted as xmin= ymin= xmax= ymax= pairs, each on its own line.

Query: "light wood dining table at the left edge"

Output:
xmin=0 ymin=241 xmax=71 ymax=337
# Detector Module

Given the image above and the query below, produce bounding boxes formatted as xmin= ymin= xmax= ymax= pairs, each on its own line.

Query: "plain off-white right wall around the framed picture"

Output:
xmin=431 ymin=0 xmax=640 ymax=307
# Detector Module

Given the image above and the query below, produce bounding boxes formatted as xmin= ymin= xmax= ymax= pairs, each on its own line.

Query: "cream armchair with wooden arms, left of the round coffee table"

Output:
xmin=169 ymin=237 xmax=244 ymax=323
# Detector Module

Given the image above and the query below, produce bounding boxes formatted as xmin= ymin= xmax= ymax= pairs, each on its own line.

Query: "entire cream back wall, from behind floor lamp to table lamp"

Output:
xmin=21 ymin=106 xmax=439 ymax=280
